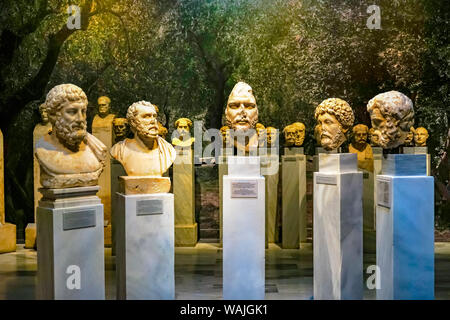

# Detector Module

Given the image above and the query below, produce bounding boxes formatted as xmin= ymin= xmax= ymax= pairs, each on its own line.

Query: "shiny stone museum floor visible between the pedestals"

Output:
xmin=0 ymin=242 xmax=450 ymax=300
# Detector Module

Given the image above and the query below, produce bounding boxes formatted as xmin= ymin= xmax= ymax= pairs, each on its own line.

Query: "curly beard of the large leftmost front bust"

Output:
xmin=55 ymin=116 xmax=87 ymax=151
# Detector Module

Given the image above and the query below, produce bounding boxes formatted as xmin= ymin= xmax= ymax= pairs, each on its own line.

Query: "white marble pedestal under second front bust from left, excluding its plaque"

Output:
xmin=116 ymin=193 xmax=175 ymax=300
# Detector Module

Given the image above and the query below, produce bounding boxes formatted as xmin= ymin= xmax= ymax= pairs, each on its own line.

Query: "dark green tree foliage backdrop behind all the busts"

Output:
xmin=0 ymin=0 xmax=450 ymax=235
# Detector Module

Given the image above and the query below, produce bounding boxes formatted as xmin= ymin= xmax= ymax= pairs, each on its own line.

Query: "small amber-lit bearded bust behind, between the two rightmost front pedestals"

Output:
xmin=348 ymin=124 xmax=373 ymax=172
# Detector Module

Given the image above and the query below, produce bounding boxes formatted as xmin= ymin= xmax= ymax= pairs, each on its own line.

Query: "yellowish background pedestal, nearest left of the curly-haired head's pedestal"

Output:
xmin=281 ymin=148 xmax=307 ymax=249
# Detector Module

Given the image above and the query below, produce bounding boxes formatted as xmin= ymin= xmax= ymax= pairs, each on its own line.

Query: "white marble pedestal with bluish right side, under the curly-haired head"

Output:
xmin=313 ymin=153 xmax=363 ymax=300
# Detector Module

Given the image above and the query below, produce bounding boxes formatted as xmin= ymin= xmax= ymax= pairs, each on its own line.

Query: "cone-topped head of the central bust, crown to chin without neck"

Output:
xmin=225 ymin=82 xmax=258 ymax=131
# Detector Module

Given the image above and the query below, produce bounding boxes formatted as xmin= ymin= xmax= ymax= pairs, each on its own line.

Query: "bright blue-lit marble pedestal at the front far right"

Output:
xmin=377 ymin=154 xmax=434 ymax=300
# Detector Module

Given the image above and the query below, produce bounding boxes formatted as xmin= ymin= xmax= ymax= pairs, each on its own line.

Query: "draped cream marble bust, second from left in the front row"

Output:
xmin=110 ymin=101 xmax=176 ymax=177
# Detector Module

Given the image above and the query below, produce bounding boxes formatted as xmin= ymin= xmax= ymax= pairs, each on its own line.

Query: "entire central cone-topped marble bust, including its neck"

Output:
xmin=225 ymin=82 xmax=258 ymax=154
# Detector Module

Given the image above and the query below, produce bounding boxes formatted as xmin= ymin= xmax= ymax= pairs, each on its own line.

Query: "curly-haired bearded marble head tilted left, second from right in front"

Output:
xmin=314 ymin=98 xmax=355 ymax=151
